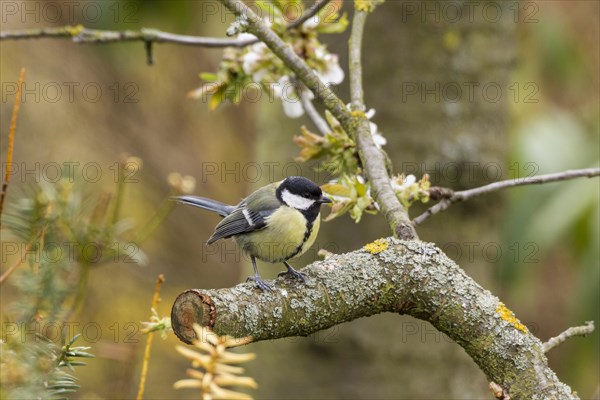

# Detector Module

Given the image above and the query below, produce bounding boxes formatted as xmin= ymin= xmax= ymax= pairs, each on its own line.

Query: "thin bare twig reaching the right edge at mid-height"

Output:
xmin=413 ymin=168 xmax=600 ymax=225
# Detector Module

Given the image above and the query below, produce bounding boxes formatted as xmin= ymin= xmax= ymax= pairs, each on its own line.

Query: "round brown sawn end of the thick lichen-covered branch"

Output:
xmin=171 ymin=289 xmax=217 ymax=344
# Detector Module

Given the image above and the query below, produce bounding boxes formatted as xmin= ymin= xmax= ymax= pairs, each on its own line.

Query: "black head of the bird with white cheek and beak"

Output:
xmin=276 ymin=176 xmax=331 ymax=211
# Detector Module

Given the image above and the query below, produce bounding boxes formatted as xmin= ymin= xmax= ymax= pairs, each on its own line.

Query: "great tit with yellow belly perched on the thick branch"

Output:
xmin=175 ymin=176 xmax=331 ymax=291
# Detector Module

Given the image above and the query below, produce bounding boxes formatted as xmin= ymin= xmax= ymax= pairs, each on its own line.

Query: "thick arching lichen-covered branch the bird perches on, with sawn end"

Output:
xmin=171 ymin=238 xmax=577 ymax=399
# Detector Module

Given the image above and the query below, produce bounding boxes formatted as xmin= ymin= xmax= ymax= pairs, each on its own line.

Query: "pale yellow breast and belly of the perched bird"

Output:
xmin=235 ymin=207 xmax=321 ymax=263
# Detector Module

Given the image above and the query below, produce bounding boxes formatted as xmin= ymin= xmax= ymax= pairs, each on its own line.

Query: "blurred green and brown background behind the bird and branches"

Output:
xmin=0 ymin=0 xmax=600 ymax=399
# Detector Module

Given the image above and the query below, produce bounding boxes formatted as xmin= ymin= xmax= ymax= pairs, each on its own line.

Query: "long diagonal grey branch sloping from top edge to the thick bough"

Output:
xmin=219 ymin=0 xmax=417 ymax=240
